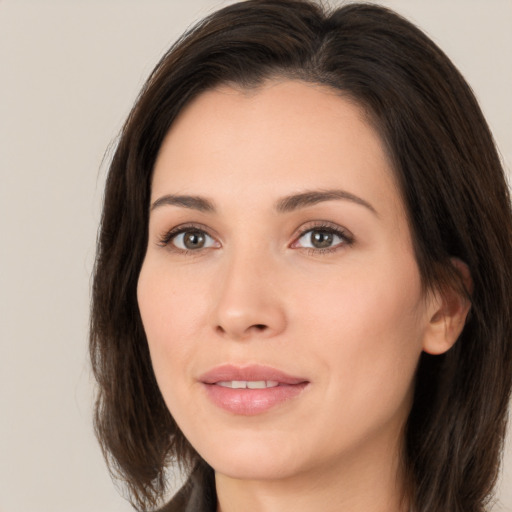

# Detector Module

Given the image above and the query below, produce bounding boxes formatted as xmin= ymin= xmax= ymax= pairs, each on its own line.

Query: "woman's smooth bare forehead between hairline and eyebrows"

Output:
xmin=152 ymin=81 xmax=401 ymax=220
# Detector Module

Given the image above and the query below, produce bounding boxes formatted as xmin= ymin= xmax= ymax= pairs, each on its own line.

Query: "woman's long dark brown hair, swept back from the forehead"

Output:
xmin=90 ymin=0 xmax=512 ymax=512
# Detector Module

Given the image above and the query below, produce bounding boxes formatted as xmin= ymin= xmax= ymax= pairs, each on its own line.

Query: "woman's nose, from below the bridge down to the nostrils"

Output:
xmin=213 ymin=247 xmax=287 ymax=341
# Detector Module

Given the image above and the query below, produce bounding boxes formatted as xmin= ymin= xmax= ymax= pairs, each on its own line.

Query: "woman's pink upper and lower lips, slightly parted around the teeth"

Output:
xmin=198 ymin=365 xmax=309 ymax=416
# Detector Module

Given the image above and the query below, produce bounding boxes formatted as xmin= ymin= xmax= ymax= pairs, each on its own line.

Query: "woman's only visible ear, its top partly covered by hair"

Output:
xmin=423 ymin=258 xmax=473 ymax=355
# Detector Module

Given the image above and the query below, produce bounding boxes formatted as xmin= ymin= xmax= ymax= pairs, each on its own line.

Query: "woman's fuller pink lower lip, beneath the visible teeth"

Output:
xmin=204 ymin=382 xmax=308 ymax=416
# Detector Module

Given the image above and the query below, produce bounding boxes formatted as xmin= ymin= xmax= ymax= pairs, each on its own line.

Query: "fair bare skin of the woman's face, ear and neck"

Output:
xmin=138 ymin=80 xmax=467 ymax=512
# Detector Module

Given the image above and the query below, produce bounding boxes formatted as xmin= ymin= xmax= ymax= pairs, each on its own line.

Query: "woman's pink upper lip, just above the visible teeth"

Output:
xmin=199 ymin=364 xmax=307 ymax=384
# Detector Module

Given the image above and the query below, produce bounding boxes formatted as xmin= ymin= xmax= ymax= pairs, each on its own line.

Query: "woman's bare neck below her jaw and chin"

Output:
xmin=215 ymin=432 xmax=408 ymax=512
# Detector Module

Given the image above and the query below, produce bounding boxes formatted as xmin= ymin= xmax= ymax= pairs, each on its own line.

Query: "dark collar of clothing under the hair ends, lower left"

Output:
xmin=158 ymin=468 xmax=217 ymax=512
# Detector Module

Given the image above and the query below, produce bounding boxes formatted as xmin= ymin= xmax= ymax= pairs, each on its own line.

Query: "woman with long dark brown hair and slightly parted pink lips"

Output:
xmin=91 ymin=0 xmax=512 ymax=512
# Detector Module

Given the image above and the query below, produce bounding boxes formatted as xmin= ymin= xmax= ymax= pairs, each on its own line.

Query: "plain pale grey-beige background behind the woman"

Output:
xmin=0 ymin=0 xmax=512 ymax=512
